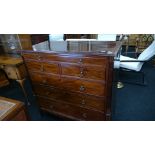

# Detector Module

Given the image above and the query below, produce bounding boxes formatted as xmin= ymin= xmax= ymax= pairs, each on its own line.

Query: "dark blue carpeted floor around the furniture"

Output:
xmin=0 ymin=46 xmax=155 ymax=121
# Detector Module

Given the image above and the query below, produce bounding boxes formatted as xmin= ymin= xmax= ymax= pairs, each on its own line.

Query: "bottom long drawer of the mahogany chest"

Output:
xmin=38 ymin=97 xmax=105 ymax=121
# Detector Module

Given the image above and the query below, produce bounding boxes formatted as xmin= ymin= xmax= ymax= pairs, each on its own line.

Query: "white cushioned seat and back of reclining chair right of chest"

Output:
xmin=114 ymin=41 xmax=155 ymax=84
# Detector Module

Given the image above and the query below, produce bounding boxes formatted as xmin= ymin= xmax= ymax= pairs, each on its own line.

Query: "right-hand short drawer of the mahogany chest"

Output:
xmin=61 ymin=63 xmax=106 ymax=80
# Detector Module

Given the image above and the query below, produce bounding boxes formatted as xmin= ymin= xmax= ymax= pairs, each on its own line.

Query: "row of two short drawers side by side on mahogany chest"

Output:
xmin=26 ymin=61 xmax=106 ymax=81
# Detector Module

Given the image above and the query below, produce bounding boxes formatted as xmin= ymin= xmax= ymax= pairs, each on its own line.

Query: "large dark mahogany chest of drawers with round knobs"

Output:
xmin=21 ymin=40 xmax=120 ymax=121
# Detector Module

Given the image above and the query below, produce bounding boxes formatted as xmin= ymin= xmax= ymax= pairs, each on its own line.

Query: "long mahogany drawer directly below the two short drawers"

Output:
xmin=30 ymin=72 xmax=106 ymax=96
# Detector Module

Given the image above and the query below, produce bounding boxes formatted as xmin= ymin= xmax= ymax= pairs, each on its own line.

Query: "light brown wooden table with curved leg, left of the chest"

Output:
xmin=0 ymin=56 xmax=30 ymax=105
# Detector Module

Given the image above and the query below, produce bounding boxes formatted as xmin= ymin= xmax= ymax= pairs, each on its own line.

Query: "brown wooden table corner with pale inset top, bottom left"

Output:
xmin=0 ymin=97 xmax=28 ymax=121
